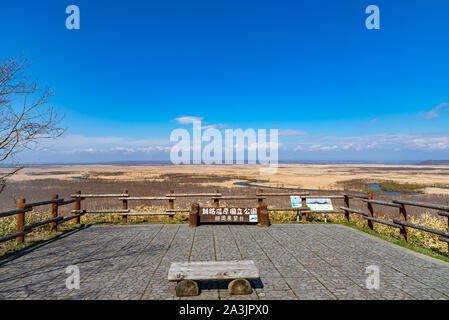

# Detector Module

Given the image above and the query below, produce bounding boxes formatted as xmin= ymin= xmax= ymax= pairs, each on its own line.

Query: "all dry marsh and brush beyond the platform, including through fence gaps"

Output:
xmin=0 ymin=164 xmax=449 ymax=252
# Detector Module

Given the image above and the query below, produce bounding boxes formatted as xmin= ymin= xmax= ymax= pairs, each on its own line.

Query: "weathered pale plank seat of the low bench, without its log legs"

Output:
xmin=168 ymin=260 xmax=260 ymax=281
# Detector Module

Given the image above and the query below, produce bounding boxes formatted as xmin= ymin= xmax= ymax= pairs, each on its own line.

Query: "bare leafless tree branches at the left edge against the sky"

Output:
xmin=0 ymin=57 xmax=65 ymax=193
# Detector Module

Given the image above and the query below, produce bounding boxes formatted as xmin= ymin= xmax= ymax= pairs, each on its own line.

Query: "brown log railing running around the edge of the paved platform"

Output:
xmin=0 ymin=189 xmax=449 ymax=256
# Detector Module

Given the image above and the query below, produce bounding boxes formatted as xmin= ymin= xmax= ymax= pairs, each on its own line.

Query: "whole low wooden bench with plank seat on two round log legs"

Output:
xmin=168 ymin=260 xmax=259 ymax=297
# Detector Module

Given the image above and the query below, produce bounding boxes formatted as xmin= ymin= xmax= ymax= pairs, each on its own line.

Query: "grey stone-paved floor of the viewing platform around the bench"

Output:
xmin=0 ymin=224 xmax=449 ymax=300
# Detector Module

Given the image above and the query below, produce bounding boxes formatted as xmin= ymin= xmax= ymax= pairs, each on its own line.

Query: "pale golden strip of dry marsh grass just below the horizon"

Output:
xmin=4 ymin=164 xmax=449 ymax=188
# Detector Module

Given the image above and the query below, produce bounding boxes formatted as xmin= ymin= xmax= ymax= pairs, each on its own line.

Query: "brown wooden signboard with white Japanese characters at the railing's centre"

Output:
xmin=200 ymin=207 xmax=259 ymax=223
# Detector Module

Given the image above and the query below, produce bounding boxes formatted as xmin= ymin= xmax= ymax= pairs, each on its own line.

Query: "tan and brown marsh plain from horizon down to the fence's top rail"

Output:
xmin=0 ymin=164 xmax=449 ymax=214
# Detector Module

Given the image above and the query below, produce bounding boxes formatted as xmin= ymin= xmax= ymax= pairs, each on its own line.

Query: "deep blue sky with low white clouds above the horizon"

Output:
xmin=0 ymin=0 xmax=449 ymax=162
